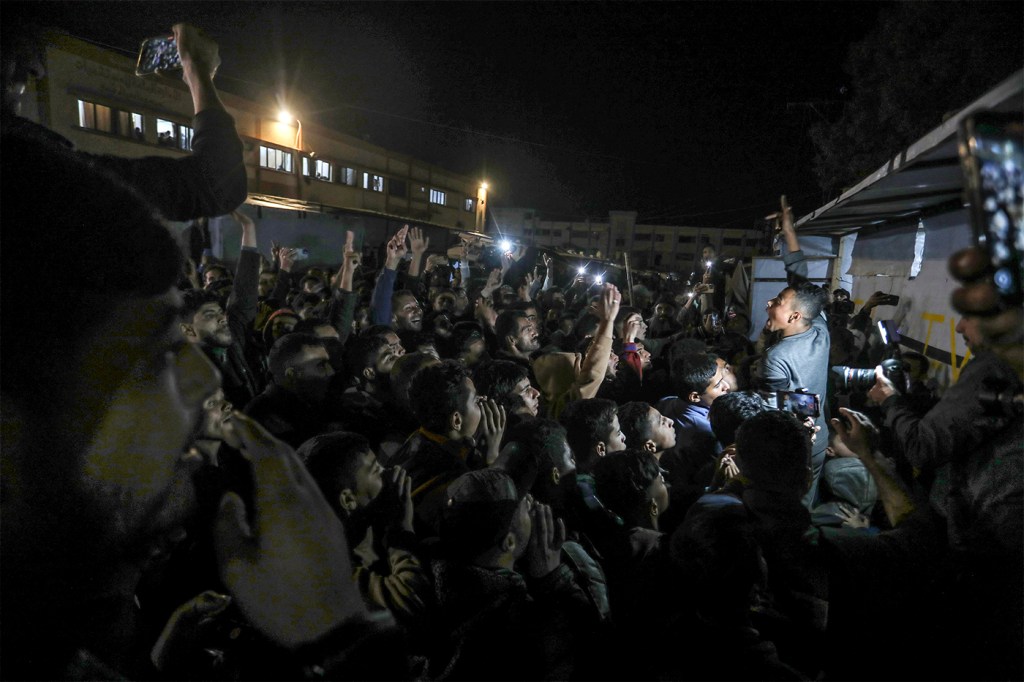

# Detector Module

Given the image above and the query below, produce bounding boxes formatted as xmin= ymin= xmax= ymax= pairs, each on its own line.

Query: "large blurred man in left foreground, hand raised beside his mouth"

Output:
xmin=0 ymin=130 xmax=387 ymax=679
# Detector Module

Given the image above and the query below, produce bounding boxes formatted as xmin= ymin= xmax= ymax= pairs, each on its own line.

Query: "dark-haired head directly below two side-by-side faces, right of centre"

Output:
xmin=594 ymin=447 xmax=669 ymax=530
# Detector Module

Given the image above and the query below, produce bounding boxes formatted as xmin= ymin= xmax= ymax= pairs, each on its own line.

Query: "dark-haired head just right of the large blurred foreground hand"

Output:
xmin=296 ymin=431 xmax=384 ymax=519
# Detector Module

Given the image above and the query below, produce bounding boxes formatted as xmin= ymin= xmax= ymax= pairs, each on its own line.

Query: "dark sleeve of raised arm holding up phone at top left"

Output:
xmin=87 ymin=109 xmax=248 ymax=220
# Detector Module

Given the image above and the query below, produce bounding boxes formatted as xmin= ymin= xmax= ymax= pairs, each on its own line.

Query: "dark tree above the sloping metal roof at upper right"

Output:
xmin=810 ymin=2 xmax=1024 ymax=194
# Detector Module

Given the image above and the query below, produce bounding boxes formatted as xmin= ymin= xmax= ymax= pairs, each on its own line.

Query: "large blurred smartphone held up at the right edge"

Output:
xmin=959 ymin=112 xmax=1024 ymax=305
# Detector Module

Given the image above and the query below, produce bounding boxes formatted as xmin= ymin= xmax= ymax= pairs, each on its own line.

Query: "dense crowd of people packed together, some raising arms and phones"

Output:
xmin=0 ymin=18 xmax=1024 ymax=680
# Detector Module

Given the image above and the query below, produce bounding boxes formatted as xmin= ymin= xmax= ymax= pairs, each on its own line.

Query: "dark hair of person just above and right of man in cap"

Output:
xmin=501 ymin=418 xmax=566 ymax=503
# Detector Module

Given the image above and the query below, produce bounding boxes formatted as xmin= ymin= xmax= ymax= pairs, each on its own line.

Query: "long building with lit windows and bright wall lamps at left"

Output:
xmin=23 ymin=35 xmax=487 ymax=262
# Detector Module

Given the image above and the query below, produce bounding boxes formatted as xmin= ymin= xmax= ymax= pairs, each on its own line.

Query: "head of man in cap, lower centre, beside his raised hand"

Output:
xmin=439 ymin=467 xmax=532 ymax=568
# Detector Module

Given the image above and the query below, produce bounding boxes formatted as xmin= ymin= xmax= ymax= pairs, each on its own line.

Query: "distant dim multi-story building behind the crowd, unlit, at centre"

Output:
xmin=490 ymin=207 xmax=764 ymax=278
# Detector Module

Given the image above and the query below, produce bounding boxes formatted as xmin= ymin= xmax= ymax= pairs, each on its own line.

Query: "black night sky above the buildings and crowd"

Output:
xmin=9 ymin=2 xmax=1021 ymax=227
